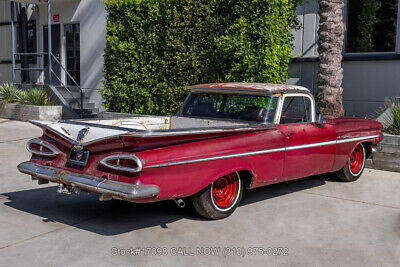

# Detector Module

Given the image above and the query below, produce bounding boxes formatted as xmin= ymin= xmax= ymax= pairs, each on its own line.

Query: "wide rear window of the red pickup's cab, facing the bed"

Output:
xmin=177 ymin=93 xmax=278 ymax=123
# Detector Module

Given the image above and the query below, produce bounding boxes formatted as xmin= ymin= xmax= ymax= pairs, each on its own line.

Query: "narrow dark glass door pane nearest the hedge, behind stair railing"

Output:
xmin=64 ymin=24 xmax=80 ymax=85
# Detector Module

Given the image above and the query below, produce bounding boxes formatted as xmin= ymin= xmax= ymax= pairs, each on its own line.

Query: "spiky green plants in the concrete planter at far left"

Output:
xmin=0 ymin=83 xmax=52 ymax=106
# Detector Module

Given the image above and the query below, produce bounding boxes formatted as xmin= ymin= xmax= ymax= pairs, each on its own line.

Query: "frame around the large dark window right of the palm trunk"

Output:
xmin=343 ymin=0 xmax=400 ymax=56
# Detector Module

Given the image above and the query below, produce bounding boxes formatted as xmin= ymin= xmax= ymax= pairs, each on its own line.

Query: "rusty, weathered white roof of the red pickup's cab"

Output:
xmin=188 ymin=83 xmax=310 ymax=94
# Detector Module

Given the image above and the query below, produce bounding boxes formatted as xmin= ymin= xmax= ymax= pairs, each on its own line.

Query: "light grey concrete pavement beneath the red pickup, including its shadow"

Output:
xmin=0 ymin=119 xmax=400 ymax=266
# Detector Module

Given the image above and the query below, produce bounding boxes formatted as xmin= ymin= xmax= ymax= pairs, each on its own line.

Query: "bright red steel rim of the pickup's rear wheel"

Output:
xmin=211 ymin=173 xmax=238 ymax=209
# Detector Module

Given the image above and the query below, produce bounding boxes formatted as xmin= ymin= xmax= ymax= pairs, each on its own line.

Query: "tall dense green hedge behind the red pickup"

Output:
xmin=103 ymin=0 xmax=300 ymax=114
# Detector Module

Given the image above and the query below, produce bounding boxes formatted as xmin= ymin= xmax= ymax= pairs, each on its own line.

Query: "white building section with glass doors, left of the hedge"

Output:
xmin=0 ymin=0 xmax=106 ymax=111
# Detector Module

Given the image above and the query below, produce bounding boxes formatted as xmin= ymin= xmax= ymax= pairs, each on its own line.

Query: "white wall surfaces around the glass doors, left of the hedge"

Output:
xmin=0 ymin=0 xmax=106 ymax=107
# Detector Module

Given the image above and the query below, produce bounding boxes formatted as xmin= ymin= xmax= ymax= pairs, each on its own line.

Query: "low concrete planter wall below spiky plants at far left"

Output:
xmin=0 ymin=103 xmax=62 ymax=121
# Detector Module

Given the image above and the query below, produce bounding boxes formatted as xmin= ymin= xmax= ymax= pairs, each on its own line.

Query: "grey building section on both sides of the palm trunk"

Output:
xmin=288 ymin=0 xmax=400 ymax=117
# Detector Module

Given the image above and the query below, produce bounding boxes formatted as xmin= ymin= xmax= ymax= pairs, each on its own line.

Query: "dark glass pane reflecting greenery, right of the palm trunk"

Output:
xmin=346 ymin=0 xmax=398 ymax=53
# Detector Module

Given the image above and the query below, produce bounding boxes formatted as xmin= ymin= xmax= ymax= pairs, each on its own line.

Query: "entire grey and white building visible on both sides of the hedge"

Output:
xmin=0 ymin=0 xmax=400 ymax=117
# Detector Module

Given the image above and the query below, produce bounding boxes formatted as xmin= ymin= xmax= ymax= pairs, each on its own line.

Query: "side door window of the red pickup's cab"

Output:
xmin=280 ymin=96 xmax=312 ymax=124
